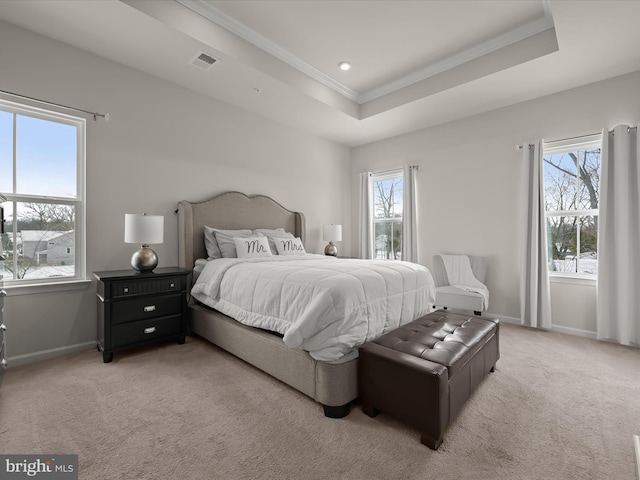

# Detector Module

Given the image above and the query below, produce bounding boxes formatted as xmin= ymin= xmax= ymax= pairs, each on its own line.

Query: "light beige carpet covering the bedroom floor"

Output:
xmin=0 ymin=324 xmax=640 ymax=480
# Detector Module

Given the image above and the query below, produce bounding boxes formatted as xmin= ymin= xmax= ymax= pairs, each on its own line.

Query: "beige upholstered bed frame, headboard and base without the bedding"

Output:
xmin=178 ymin=192 xmax=435 ymax=418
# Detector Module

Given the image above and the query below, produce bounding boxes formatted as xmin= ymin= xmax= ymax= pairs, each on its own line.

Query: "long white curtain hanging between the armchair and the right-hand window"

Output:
xmin=520 ymin=141 xmax=551 ymax=328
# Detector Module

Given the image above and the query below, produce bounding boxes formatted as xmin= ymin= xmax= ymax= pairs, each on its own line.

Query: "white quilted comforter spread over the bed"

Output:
xmin=191 ymin=255 xmax=435 ymax=362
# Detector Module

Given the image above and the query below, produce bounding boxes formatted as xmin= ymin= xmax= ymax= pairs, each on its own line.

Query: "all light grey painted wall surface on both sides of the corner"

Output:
xmin=0 ymin=17 xmax=640 ymax=365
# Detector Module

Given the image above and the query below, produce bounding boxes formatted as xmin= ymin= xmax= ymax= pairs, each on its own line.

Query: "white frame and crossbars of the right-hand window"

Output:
xmin=542 ymin=133 xmax=602 ymax=282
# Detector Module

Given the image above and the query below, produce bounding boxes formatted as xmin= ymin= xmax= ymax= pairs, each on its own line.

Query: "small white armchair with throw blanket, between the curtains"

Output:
xmin=433 ymin=255 xmax=489 ymax=315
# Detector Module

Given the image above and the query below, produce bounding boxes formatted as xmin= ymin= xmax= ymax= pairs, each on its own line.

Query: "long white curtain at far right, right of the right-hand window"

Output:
xmin=596 ymin=125 xmax=640 ymax=345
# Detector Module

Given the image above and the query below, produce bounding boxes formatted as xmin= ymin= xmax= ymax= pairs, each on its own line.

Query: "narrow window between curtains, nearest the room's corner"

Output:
xmin=372 ymin=170 xmax=403 ymax=260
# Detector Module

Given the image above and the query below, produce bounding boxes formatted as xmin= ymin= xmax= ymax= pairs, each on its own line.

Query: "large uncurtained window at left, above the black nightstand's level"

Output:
xmin=0 ymin=100 xmax=86 ymax=286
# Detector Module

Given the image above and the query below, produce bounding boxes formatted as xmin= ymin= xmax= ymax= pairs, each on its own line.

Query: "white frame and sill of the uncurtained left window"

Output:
xmin=0 ymin=99 xmax=89 ymax=288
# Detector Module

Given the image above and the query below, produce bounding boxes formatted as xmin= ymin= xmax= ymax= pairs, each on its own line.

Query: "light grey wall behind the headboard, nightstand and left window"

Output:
xmin=0 ymin=18 xmax=351 ymax=365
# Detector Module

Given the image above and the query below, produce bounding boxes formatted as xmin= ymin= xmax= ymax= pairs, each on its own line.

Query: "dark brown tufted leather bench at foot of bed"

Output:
xmin=358 ymin=310 xmax=500 ymax=450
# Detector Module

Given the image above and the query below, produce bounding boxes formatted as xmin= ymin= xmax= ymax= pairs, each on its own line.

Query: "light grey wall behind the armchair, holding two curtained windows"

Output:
xmin=351 ymin=72 xmax=640 ymax=334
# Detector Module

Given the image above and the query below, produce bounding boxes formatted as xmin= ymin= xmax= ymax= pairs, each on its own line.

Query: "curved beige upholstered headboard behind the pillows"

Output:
xmin=178 ymin=192 xmax=306 ymax=269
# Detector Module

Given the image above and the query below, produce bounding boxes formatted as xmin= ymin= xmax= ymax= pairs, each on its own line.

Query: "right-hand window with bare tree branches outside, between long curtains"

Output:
xmin=543 ymin=135 xmax=601 ymax=275
